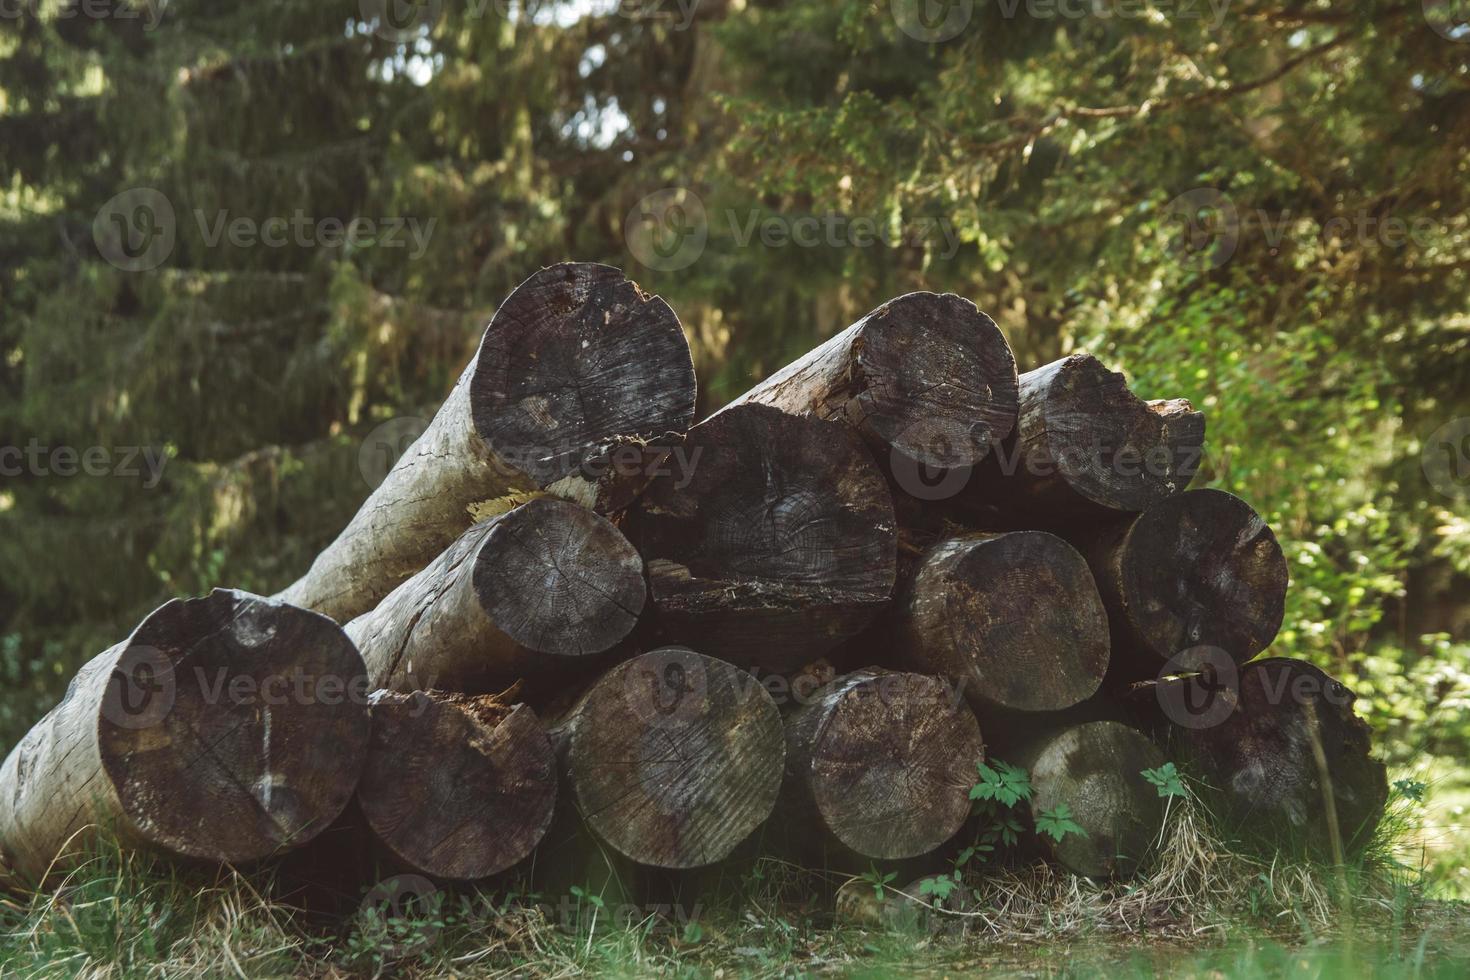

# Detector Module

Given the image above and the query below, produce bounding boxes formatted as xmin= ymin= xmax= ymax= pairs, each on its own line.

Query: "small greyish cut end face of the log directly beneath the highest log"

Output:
xmin=475 ymin=498 xmax=647 ymax=657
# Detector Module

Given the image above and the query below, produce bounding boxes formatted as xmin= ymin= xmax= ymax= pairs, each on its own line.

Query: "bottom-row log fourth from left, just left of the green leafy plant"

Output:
xmin=784 ymin=669 xmax=985 ymax=860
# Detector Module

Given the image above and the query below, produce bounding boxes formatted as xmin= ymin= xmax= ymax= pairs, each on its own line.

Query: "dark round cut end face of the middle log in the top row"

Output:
xmin=845 ymin=292 xmax=1017 ymax=470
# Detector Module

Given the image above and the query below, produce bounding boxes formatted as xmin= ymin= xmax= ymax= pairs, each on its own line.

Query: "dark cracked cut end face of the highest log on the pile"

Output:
xmin=470 ymin=262 xmax=695 ymax=488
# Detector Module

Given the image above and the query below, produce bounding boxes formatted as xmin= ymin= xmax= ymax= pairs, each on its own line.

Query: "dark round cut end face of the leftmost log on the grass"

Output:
xmin=98 ymin=589 xmax=369 ymax=862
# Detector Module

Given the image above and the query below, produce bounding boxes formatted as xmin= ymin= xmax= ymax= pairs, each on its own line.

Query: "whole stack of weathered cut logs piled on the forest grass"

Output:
xmin=0 ymin=263 xmax=1385 ymax=884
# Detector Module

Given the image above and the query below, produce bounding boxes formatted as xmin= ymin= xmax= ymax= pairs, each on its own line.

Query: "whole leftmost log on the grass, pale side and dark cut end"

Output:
xmin=0 ymin=589 xmax=369 ymax=883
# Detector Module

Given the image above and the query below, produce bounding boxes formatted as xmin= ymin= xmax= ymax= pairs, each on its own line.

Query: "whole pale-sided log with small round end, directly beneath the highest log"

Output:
xmin=345 ymin=498 xmax=647 ymax=693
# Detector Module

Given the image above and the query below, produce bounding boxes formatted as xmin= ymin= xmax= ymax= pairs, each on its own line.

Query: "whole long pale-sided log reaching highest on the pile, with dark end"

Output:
xmin=281 ymin=263 xmax=694 ymax=623
